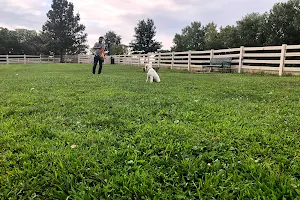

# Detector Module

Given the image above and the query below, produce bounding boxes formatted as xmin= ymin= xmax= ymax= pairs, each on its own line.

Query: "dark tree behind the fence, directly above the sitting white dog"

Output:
xmin=130 ymin=19 xmax=162 ymax=53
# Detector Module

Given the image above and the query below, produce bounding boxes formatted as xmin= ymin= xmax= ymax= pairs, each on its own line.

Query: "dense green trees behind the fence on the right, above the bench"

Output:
xmin=172 ymin=0 xmax=300 ymax=51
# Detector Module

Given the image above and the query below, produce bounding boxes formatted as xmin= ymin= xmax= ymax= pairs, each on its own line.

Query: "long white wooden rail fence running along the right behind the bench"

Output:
xmin=113 ymin=44 xmax=300 ymax=76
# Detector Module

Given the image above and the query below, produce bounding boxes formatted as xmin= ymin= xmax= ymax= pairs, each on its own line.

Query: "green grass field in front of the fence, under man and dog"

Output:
xmin=0 ymin=64 xmax=300 ymax=200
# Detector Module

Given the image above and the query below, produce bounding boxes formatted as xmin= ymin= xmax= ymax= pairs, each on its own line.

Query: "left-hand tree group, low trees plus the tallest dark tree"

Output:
xmin=0 ymin=0 xmax=88 ymax=62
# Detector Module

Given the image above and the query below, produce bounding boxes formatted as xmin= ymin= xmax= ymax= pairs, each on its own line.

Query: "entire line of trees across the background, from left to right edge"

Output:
xmin=0 ymin=0 xmax=300 ymax=56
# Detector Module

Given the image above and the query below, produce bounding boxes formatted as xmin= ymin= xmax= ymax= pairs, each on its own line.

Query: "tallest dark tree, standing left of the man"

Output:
xmin=43 ymin=0 xmax=87 ymax=62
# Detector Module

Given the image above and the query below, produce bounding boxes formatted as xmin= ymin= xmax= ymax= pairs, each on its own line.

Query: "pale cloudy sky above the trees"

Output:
xmin=0 ymin=0 xmax=285 ymax=49
